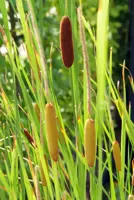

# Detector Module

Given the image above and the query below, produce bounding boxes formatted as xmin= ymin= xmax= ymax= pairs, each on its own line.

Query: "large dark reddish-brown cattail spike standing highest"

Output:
xmin=60 ymin=16 xmax=74 ymax=67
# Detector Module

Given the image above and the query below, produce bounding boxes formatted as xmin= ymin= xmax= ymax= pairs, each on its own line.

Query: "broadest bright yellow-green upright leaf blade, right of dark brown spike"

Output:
xmin=96 ymin=0 xmax=109 ymax=200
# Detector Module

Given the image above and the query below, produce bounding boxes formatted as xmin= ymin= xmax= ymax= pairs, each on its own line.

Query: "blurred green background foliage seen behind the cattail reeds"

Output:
xmin=0 ymin=0 xmax=129 ymax=121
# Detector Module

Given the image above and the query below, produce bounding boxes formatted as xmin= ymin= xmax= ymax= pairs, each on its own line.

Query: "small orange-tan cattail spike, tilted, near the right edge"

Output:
xmin=113 ymin=141 xmax=121 ymax=171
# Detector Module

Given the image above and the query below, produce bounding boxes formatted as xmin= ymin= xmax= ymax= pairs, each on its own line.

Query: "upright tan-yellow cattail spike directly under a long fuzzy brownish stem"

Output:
xmin=84 ymin=119 xmax=96 ymax=167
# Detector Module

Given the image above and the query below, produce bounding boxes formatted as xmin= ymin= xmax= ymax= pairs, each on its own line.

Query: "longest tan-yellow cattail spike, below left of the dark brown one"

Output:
xmin=45 ymin=103 xmax=58 ymax=161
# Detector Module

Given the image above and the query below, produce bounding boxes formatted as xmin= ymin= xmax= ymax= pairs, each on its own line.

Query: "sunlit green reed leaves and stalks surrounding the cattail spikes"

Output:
xmin=0 ymin=0 xmax=134 ymax=200
